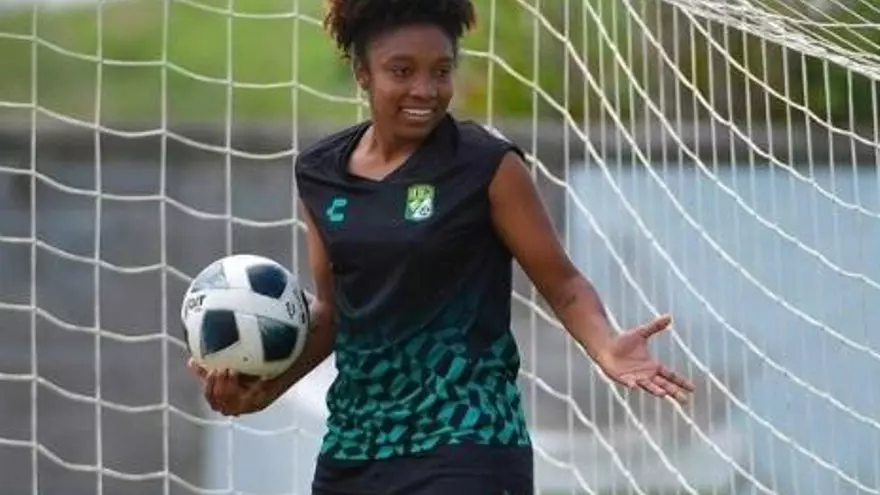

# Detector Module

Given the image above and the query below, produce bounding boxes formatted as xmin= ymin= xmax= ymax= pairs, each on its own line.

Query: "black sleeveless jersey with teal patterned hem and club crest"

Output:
xmin=296 ymin=116 xmax=529 ymax=459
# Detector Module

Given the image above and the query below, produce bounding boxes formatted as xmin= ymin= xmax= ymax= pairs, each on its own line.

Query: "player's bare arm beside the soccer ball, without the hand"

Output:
xmin=266 ymin=206 xmax=336 ymax=393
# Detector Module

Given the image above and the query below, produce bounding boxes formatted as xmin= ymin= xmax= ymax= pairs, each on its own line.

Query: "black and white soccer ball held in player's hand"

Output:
xmin=180 ymin=254 xmax=310 ymax=378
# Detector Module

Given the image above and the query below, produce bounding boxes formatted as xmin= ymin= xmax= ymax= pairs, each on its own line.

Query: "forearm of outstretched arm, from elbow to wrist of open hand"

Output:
xmin=548 ymin=274 xmax=614 ymax=362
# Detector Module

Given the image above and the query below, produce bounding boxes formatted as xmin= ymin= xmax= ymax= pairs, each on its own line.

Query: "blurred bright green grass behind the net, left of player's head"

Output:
xmin=0 ymin=0 xmax=354 ymax=121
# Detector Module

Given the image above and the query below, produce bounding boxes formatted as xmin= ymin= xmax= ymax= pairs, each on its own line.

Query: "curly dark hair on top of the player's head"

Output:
xmin=324 ymin=0 xmax=477 ymax=60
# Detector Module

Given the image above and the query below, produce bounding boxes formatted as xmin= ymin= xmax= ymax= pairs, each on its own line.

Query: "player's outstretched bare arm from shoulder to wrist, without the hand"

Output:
xmin=489 ymin=152 xmax=614 ymax=364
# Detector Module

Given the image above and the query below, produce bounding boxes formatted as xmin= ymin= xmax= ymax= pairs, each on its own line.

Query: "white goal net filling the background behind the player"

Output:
xmin=0 ymin=0 xmax=880 ymax=495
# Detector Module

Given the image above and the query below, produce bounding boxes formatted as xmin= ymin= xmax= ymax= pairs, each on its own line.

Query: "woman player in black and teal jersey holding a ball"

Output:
xmin=196 ymin=0 xmax=693 ymax=495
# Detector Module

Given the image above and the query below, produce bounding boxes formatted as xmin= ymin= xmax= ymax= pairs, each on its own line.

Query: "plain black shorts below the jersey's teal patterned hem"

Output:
xmin=312 ymin=444 xmax=534 ymax=495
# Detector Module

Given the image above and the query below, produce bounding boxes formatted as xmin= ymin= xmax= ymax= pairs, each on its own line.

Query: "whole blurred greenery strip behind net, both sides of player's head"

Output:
xmin=0 ymin=0 xmax=880 ymax=125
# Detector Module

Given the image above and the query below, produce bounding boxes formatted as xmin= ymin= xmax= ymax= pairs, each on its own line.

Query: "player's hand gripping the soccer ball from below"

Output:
xmin=187 ymin=359 xmax=284 ymax=416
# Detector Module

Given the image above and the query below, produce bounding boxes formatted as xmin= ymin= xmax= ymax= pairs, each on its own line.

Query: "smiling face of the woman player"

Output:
xmin=355 ymin=25 xmax=455 ymax=140
